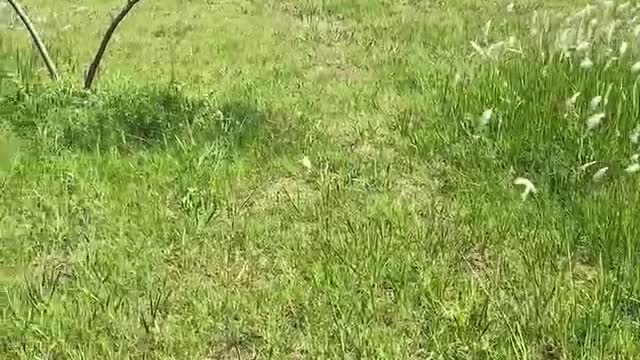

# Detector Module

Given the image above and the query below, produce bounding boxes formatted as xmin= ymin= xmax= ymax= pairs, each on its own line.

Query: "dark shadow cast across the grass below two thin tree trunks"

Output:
xmin=0 ymin=85 xmax=302 ymax=152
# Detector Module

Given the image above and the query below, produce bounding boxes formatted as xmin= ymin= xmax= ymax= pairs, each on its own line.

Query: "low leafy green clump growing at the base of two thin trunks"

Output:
xmin=3 ymin=83 xmax=201 ymax=150
